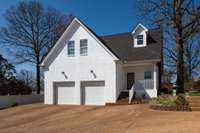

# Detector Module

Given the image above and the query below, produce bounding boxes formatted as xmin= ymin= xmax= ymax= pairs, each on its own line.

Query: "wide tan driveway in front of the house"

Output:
xmin=0 ymin=104 xmax=200 ymax=133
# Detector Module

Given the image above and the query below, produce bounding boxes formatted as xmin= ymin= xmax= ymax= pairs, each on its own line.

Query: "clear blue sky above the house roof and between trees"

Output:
xmin=0 ymin=0 xmax=145 ymax=70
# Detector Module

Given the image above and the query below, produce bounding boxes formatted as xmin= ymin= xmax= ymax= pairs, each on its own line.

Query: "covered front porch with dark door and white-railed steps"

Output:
xmin=114 ymin=62 xmax=159 ymax=103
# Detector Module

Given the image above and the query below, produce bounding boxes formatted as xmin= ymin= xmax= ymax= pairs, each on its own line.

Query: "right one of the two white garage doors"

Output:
xmin=82 ymin=81 xmax=105 ymax=105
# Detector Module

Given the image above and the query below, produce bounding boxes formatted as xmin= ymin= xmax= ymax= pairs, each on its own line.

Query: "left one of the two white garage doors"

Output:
xmin=55 ymin=82 xmax=76 ymax=104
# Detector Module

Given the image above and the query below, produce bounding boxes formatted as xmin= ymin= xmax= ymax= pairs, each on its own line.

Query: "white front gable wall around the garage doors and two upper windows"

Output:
xmin=44 ymin=24 xmax=116 ymax=104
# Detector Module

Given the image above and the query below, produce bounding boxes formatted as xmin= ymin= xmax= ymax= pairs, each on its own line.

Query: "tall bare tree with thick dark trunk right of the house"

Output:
xmin=139 ymin=0 xmax=200 ymax=93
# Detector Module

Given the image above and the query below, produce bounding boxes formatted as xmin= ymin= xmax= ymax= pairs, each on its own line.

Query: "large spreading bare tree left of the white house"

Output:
xmin=0 ymin=1 xmax=73 ymax=94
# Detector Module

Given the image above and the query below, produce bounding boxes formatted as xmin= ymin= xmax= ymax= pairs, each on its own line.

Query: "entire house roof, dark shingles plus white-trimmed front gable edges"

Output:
xmin=41 ymin=18 xmax=162 ymax=66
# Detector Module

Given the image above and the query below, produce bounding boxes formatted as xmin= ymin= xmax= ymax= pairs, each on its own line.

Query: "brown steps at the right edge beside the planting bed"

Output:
xmin=187 ymin=96 xmax=200 ymax=111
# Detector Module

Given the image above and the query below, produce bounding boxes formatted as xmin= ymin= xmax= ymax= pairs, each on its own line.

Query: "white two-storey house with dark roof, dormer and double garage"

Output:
xmin=41 ymin=18 xmax=162 ymax=105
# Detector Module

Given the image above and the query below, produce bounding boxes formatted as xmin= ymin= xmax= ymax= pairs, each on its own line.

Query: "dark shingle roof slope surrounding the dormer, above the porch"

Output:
xmin=100 ymin=29 xmax=162 ymax=61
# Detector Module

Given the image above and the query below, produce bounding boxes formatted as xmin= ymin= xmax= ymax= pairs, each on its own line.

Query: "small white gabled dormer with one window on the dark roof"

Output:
xmin=132 ymin=24 xmax=148 ymax=48
